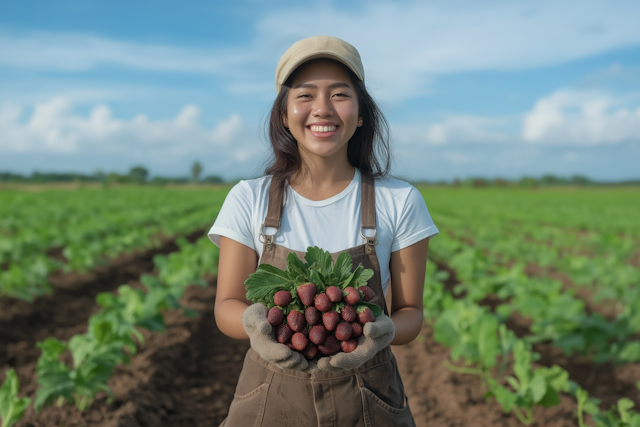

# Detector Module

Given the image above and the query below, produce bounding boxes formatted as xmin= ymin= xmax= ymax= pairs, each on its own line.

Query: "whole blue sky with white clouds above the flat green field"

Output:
xmin=0 ymin=0 xmax=640 ymax=180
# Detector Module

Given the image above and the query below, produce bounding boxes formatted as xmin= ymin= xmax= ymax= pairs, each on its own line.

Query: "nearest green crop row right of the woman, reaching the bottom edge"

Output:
xmin=423 ymin=241 xmax=640 ymax=427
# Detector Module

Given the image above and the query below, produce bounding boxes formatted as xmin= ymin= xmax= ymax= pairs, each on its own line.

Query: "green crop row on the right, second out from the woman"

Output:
xmin=432 ymin=232 xmax=640 ymax=363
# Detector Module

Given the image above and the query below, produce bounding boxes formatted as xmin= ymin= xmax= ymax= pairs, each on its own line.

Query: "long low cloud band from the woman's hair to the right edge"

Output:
xmin=392 ymin=89 xmax=640 ymax=147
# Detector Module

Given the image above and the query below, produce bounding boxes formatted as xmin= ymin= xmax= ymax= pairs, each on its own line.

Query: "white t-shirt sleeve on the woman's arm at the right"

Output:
xmin=391 ymin=186 xmax=439 ymax=252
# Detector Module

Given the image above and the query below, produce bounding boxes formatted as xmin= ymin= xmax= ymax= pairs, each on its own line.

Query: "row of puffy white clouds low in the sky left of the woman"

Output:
xmin=0 ymin=98 xmax=242 ymax=155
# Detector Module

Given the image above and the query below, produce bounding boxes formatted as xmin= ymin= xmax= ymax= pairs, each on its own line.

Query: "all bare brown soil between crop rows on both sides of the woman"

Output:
xmin=0 ymin=256 xmax=640 ymax=427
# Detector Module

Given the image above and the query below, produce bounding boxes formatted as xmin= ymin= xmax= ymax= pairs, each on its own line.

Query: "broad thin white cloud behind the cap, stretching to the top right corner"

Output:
xmin=258 ymin=0 xmax=640 ymax=100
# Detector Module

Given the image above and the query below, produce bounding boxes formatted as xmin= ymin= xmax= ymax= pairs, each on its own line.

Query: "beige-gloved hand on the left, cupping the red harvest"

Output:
xmin=242 ymin=304 xmax=309 ymax=371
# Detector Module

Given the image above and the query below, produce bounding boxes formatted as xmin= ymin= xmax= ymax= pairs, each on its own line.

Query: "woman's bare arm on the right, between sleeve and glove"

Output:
xmin=387 ymin=238 xmax=429 ymax=345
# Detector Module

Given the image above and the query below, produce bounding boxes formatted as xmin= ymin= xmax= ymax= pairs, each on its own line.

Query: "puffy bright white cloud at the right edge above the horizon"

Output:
xmin=522 ymin=90 xmax=640 ymax=145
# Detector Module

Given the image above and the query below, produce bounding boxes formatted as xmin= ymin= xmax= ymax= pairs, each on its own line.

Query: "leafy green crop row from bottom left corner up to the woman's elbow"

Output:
xmin=0 ymin=237 xmax=219 ymax=427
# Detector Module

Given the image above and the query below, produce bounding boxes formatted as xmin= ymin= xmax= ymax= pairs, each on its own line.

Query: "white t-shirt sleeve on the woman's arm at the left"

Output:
xmin=209 ymin=181 xmax=256 ymax=250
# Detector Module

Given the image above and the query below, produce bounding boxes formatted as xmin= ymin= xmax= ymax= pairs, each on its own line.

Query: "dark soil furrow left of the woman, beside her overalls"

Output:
xmin=11 ymin=278 xmax=249 ymax=427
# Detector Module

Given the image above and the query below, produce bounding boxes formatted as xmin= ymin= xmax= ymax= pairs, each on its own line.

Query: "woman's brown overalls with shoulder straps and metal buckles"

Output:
xmin=220 ymin=174 xmax=415 ymax=427
